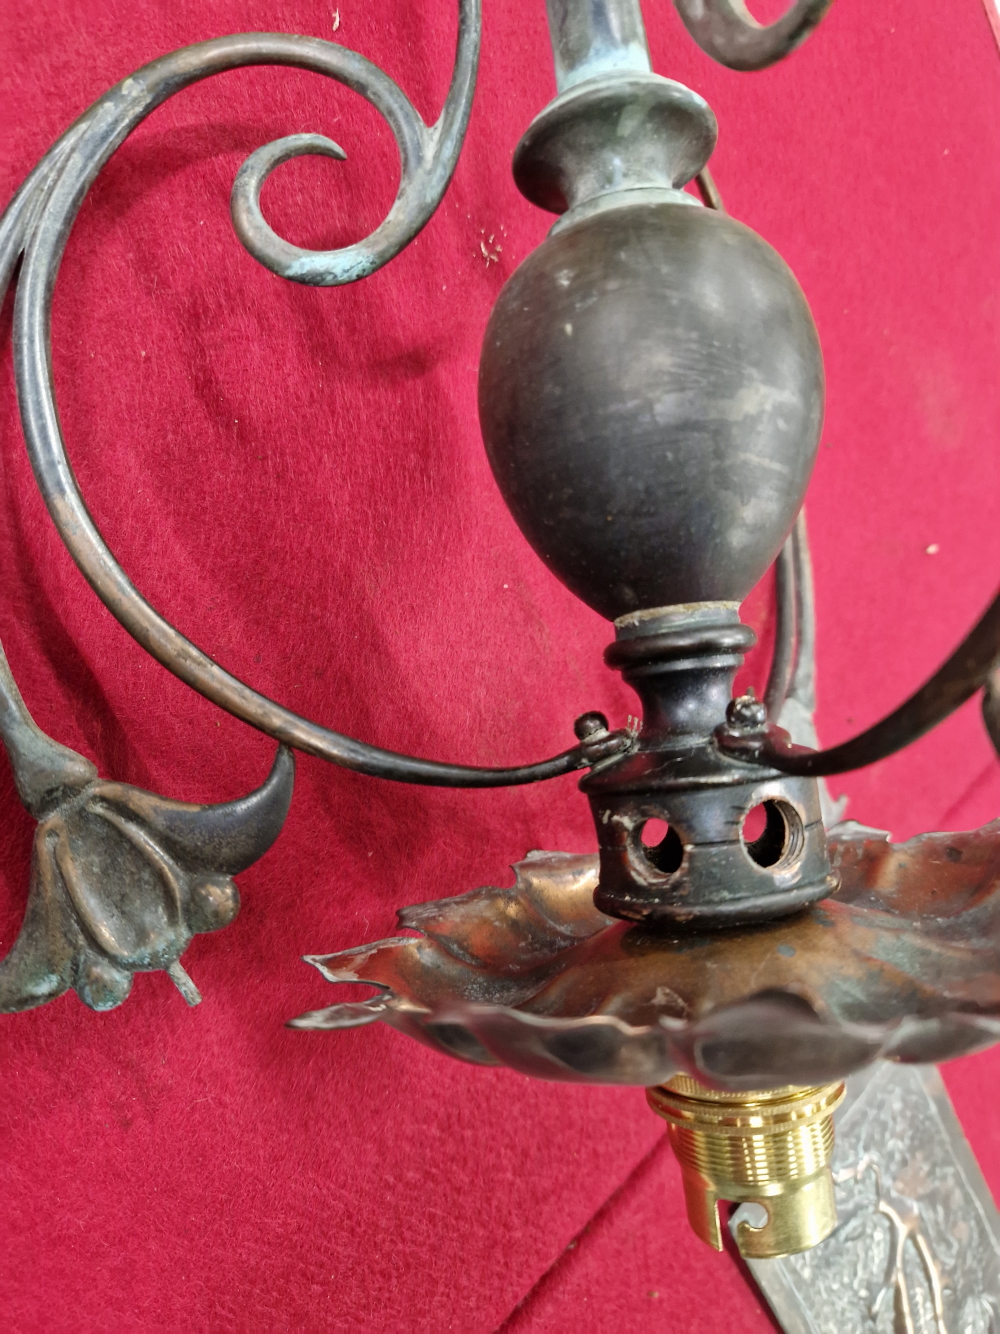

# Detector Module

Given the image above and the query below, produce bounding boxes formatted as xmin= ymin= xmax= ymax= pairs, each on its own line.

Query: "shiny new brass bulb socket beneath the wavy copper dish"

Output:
xmin=645 ymin=1075 xmax=844 ymax=1259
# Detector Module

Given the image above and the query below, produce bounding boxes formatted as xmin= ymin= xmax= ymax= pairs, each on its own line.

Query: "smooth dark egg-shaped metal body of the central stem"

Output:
xmin=479 ymin=201 xmax=823 ymax=619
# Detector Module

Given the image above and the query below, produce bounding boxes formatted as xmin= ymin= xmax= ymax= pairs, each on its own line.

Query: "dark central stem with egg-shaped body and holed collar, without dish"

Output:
xmin=480 ymin=5 xmax=835 ymax=924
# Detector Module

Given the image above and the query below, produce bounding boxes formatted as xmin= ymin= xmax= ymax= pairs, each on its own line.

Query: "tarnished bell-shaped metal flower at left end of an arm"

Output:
xmin=0 ymin=634 xmax=295 ymax=1013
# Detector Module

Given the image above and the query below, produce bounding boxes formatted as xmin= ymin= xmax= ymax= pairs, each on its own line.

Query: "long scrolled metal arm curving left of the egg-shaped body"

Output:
xmin=0 ymin=20 xmax=632 ymax=787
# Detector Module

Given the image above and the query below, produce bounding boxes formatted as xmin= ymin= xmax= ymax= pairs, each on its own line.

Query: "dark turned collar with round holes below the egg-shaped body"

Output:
xmin=580 ymin=606 xmax=836 ymax=926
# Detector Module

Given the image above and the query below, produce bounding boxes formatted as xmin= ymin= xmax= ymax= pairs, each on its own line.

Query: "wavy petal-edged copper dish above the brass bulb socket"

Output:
xmin=293 ymin=822 xmax=1000 ymax=1089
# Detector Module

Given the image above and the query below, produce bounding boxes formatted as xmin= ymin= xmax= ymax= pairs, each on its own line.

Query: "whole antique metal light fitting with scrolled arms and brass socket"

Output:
xmin=0 ymin=0 xmax=1000 ymax=1291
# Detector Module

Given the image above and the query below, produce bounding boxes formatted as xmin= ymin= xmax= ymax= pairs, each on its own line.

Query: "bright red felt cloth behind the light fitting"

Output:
xmin=0 ymin=0 xmax=1000 ymax=1334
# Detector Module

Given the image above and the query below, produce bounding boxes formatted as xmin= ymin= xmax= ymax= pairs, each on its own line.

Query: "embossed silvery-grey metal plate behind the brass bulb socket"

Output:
xmin=732 ymin=1063 xmax=1000 ymax=1334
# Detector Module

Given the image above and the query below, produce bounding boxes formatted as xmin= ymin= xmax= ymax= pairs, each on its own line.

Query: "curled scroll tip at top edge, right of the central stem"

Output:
xmin=673 ymin=0 xmax=833 ymax=69
